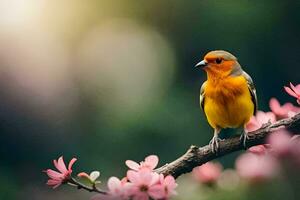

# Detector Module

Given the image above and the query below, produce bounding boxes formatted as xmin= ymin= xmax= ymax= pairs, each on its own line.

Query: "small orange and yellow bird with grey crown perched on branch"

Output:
xmin=195 ymin=50 xmax=257 ymax=153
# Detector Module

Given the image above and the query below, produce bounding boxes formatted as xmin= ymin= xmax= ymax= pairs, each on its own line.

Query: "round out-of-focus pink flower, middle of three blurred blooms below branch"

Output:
xmin=236 ymin=153 xmax=278 ymax=182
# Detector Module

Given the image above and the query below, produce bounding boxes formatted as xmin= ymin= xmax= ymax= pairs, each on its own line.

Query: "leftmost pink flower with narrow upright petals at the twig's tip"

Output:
xmin=44 ymin=156 xmax=77 ymax=188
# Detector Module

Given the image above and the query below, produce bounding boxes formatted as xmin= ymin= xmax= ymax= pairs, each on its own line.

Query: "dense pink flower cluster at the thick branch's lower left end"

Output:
xmin=93 ymin=155 xmax=177 ymax=200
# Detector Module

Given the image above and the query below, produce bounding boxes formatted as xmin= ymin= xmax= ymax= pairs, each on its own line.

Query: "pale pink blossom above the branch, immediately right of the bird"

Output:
xmin=245 ymin=111 xmax=276 ymax=132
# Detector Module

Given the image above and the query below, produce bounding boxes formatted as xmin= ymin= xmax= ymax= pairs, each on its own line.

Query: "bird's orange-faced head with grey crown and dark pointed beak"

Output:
xmin=195 ymin=50 xmax=240 ymax=75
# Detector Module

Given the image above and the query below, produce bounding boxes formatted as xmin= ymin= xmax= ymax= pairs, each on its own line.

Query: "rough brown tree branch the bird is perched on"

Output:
xmin=156 ymin=113 xmax=300 ymax=178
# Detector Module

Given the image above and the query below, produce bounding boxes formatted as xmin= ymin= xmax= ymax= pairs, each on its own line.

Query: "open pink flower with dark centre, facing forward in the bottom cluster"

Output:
xmin=127 ymin=169 xmax=164 ymax=200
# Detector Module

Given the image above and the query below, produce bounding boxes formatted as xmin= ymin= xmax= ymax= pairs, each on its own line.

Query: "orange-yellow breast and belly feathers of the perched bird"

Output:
xmin=204 ymin=76 xmax=254 ymax=128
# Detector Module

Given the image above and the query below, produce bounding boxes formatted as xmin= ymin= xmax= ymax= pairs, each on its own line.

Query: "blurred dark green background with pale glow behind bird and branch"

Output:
xmin=0 ymin=0 xmax=300 ymax=200
